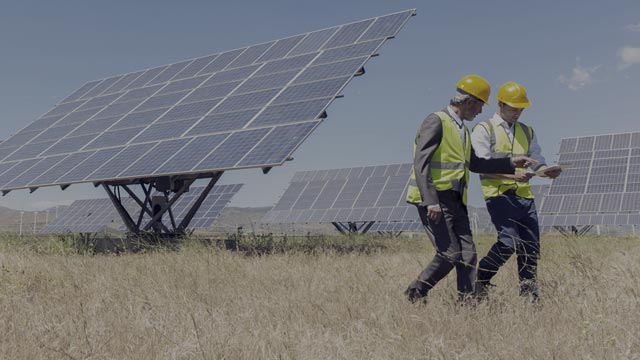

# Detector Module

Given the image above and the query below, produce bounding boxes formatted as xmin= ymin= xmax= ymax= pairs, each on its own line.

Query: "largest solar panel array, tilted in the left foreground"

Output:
xmin=0 ymin=10 xmax=414 ymax=191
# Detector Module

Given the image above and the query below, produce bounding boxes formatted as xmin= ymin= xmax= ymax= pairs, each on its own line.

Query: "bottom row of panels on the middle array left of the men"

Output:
xmin=262 ymin=206 xmax=420 ymax=223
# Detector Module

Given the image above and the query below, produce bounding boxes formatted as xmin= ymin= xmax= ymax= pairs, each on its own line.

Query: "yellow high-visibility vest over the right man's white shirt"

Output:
xmin=476 ymin=120 xmax=534 ymax=200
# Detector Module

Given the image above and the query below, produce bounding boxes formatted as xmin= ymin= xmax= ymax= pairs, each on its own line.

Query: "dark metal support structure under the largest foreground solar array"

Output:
xmin=99 ymin=172 xmax=223 ymax=239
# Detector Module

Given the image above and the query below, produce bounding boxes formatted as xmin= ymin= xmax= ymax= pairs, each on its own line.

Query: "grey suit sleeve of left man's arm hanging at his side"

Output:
xmin=413 ymin=114 xmax=442 ymax=207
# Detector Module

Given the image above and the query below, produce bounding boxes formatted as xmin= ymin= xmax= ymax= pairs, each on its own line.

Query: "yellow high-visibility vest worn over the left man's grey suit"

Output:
xmin=407 ymin=111 xmax=471 ymax=205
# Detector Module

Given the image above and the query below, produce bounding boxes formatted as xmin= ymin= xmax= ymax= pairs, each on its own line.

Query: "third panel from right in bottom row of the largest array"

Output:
xmin=154 ymin=133 xmax=229 ymax=174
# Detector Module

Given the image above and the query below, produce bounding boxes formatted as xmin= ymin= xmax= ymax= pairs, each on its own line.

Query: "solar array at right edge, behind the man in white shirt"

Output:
xmin=540 ymin=132 xmax=640 ymax=226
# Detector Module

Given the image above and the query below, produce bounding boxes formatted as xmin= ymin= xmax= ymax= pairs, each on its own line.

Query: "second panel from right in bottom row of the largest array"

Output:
xmin=194 ymin=129 xmax=269 ymax=170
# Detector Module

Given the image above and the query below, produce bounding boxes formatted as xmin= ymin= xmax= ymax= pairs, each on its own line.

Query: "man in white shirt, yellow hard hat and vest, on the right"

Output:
xmin=471 ymin=81 xmax=561 ymax=301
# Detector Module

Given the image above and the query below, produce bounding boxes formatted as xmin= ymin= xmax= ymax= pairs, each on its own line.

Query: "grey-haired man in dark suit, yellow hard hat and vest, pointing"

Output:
xmin=405 ymin=75 xmax=534 ymax=302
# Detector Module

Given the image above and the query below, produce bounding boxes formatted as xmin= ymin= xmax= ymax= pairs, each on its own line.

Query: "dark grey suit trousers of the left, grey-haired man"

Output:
xmin=407 ymin=191 xmax=477 ymax=296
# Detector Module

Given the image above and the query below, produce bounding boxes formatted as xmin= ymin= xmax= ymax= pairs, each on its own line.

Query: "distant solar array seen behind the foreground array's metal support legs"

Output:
xmin=41 ymin=184 xmax=242 ymax=234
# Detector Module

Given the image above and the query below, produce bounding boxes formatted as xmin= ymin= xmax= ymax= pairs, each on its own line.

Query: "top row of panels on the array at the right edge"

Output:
xmin=559 ymin=132 xmax=640 ymax=154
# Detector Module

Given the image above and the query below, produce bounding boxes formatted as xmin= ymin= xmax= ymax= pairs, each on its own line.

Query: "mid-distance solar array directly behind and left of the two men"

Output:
xmin=262 ymin=164 xmax=419 ymax=223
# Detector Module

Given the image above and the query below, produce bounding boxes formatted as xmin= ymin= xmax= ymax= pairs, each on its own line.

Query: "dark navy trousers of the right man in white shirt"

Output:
xmin=478 ymin=192 xmax=540 ymax=283
